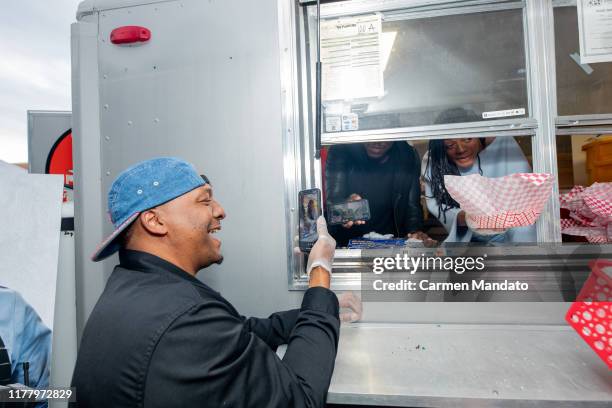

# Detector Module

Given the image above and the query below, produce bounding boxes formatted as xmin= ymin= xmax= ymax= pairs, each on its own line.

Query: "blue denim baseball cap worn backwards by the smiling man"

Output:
xmin=91 ymin=157 xmax=208 ymax=262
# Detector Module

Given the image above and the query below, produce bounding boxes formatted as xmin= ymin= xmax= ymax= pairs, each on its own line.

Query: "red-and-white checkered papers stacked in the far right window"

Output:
xmin=559 ymin=183 xmax=612 ymax=244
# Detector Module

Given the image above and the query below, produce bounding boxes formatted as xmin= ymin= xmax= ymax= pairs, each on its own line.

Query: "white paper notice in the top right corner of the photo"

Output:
xmin=577 ymin=0 xmax=612 ymax=64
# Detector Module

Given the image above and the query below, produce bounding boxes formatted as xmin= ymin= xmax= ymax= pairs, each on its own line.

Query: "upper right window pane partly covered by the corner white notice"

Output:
xmin=554 ymin=6 xmax=612 ymax=116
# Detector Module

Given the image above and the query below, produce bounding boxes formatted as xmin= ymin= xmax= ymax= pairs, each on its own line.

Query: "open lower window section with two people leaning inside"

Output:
xmin=321 ymin=136 xmax=537 ymax=249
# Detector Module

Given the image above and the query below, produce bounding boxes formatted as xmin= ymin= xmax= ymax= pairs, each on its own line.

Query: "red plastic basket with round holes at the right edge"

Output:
xmin=565 ymin=260 xmax=612 ymax=370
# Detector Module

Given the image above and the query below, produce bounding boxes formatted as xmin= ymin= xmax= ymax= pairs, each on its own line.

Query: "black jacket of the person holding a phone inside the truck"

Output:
xmin=325 ymin=142 xmax=423 ymax=241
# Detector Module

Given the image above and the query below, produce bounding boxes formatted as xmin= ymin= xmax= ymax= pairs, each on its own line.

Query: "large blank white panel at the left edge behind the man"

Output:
xmin=0 ymin=165 xmax=64 ymax=329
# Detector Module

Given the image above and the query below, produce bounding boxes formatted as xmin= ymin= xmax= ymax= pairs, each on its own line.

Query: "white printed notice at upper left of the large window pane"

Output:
xmin=321 ymin=14 xmax=384 ymax=101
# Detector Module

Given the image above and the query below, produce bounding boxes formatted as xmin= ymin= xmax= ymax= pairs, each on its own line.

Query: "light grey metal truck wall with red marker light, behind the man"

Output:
xmin=91 ymin=0 xmax=301 ymax=314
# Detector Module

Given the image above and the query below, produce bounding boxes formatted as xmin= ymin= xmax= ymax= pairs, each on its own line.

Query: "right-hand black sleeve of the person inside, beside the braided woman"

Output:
xmin=403 ymin=146 xmax=423 ymax=234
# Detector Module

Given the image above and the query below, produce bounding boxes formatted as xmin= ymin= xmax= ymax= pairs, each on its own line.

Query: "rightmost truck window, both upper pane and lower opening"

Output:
xmin=553 ymin=0 xmax=612 ymax=244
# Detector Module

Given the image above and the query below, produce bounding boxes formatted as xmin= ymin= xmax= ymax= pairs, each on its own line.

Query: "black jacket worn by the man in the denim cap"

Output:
xmin=72 ymin=251 xmax=340 ymax=408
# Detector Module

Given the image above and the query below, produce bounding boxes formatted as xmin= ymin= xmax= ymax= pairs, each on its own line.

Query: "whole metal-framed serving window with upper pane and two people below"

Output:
xmin=281 ymin=0 xmax=612 ymax=288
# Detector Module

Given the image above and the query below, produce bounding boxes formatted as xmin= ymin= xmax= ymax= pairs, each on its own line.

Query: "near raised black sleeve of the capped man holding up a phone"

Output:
xmin=144 ymin=288 xmax=340 ymax=408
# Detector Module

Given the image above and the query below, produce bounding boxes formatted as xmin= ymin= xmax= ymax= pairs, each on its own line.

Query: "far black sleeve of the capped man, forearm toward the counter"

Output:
xmin=244 ymin=309 xmax=300 ymax=349
